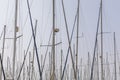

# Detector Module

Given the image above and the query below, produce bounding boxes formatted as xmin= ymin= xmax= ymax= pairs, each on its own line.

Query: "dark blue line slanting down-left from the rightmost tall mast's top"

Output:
xmin=90 ymin=3 xmax=101 ymax=80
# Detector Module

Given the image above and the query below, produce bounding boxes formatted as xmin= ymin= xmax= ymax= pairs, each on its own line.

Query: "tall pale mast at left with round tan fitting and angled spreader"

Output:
xmin=13 ymin=0 xmax=18 ymax=80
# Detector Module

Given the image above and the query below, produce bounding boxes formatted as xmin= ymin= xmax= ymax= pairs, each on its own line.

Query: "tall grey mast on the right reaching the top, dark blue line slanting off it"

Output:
xmin=101 ymin=0 xmax=104 ymax=80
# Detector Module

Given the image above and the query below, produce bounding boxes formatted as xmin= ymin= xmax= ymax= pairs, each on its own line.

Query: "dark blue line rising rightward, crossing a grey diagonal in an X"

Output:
xmin=61 ymin=1 xmax=77 ymax=80
